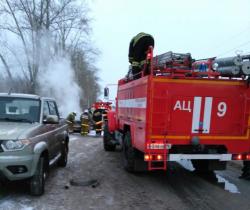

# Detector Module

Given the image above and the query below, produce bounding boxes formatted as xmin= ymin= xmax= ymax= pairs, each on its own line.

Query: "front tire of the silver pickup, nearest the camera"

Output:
xmin=29 ymin=157 xmax=46 ymax=196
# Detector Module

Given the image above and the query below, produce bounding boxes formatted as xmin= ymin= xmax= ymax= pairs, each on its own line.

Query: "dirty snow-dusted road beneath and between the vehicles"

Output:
xmin=0 ymin=134 xmax=250 ymax=210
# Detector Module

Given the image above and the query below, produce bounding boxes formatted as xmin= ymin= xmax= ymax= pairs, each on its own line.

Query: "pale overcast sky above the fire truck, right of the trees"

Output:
xmin=89 ymin=0 xmax=250 ymax=99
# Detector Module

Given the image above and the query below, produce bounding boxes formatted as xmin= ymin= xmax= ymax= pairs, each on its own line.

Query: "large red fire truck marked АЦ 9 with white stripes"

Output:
xmin=103 ymin=48 xmax=250 ymax=172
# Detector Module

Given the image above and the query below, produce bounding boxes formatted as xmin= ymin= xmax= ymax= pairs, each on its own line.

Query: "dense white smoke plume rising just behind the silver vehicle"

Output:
xmin=39 ymin=57 xmax=81 ymax=117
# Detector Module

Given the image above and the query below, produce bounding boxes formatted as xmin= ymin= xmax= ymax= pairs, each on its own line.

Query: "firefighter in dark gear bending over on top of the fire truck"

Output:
xmin=128 ymin=32 xmax=154 ymax=79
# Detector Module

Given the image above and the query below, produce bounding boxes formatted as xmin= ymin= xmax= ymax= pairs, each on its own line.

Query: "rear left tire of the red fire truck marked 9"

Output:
xmin=122 ymin=131 xmax=136 ymax=172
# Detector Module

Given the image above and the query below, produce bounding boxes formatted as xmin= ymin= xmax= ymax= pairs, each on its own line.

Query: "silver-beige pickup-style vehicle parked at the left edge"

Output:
xmin=0 ymin=93 xmax=69 ymax=195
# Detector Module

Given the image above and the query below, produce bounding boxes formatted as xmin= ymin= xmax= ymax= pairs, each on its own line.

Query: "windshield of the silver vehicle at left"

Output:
xmin=0 ymin=97 xmax=40 ymax=123
